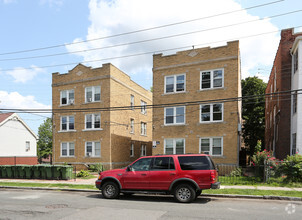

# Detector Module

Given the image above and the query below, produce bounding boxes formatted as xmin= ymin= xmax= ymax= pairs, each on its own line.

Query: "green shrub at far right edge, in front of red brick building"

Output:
xmin=278 ymin=154 xmax=302 ymax=182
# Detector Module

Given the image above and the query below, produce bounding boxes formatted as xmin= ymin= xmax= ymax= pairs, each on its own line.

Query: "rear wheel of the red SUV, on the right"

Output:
xmin=174 ymin=184 xmax=196 ymax=203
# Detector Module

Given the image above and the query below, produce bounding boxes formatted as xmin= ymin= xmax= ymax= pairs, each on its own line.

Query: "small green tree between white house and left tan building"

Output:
xmin=37 ymin=118 xmax=52 ymax=163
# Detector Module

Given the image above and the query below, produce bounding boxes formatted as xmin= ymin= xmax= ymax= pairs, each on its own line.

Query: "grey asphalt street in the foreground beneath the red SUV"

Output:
xmin=0 ymin=189 xmax=302 ymax=220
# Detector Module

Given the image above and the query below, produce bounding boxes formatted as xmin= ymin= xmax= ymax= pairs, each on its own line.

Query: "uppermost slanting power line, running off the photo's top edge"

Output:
xmin=0 ymin=0 xmax=284 ymax=56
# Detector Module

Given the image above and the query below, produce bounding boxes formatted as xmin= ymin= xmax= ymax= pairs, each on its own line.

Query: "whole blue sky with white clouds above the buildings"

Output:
xmin=0 ymin=0 xmax=302 ymax=133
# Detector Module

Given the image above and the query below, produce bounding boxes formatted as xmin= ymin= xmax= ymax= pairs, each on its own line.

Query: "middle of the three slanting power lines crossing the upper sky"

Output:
xmin=0 ymin=10 xmax=302 ymax=61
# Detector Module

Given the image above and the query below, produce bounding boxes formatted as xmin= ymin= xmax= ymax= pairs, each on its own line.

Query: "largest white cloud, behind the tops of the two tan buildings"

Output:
xmin=66 ymin=0 xmax=279 ymax=81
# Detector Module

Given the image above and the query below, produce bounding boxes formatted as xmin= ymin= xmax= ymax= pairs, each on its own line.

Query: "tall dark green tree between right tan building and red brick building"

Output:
xmin=241 ymin=76 xmax=266 ymax=156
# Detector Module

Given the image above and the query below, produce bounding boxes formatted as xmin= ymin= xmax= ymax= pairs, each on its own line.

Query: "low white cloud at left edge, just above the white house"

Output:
xmin=0 ymin=91 xmax=51 ymax=109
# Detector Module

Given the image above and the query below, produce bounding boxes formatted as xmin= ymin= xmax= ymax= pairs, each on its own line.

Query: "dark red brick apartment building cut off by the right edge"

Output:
xmin=265 ymin=29 xmax=302 ymax=159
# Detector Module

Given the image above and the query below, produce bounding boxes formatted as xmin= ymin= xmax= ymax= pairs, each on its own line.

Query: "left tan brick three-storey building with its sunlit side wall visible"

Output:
xmin=52 ymin=64 xmax=152 ymax=169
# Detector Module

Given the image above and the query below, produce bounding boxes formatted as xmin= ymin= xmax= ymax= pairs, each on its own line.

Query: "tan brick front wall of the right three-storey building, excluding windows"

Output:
xmin=152 ymin=41 xmax=241 ymax=164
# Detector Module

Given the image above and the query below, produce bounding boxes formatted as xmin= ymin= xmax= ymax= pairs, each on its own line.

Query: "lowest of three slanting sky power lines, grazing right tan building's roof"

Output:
xmin=2 ymin=26 xmax=302 ymax=71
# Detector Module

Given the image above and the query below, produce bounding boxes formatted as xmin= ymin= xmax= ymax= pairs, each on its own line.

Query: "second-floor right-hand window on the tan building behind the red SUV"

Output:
xmin=200 ymin=103 xmax=223 ymax=123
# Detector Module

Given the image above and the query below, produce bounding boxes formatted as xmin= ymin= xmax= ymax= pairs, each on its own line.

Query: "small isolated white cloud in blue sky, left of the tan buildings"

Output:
xmin=5 ymin=65 xmax=46 ymax=83
